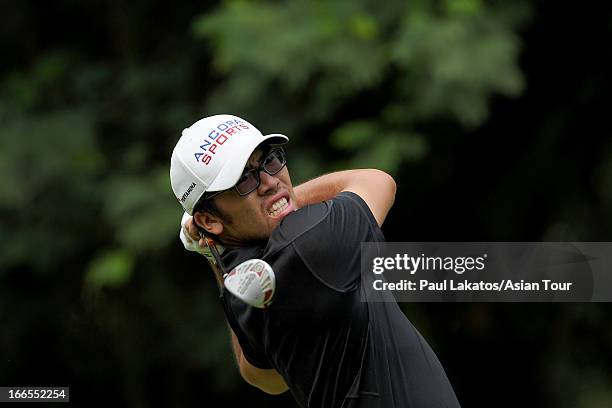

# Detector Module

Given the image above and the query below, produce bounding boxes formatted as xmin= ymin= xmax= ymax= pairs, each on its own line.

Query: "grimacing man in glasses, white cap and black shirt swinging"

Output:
xmin=170 ymin=115 xmax=459 ymax=408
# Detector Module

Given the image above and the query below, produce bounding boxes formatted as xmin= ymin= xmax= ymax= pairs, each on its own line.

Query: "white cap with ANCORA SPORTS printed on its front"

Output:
xmin=170 ymin=115 xmax=289 ymax=215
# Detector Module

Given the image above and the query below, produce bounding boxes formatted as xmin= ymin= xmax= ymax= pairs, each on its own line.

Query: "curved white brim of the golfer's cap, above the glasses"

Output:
xmin=206 ymin=133 xmax=289 ymax=192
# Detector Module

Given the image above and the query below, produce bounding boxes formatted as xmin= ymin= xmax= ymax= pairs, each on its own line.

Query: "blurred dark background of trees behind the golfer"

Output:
xmin=0 ymin=0 xmax=612 ymax=408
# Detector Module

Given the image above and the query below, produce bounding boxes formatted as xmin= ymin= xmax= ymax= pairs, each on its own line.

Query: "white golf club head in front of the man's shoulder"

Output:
xmin=223 ymin=258 xmax=276 ymax=309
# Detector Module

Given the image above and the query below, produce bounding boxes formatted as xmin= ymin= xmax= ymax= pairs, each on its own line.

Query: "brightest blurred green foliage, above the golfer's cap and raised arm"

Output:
xmin=194 ymin=0 xmax=529 ymax=174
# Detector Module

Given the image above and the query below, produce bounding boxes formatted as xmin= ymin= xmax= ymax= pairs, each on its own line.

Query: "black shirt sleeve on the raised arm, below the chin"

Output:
xmin=293 ymin=191 xmax=384 ymax=292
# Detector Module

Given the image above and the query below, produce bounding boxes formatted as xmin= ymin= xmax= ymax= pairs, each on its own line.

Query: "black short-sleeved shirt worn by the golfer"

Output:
xmin=222 ymin=192 xmax=459 ymax=408
